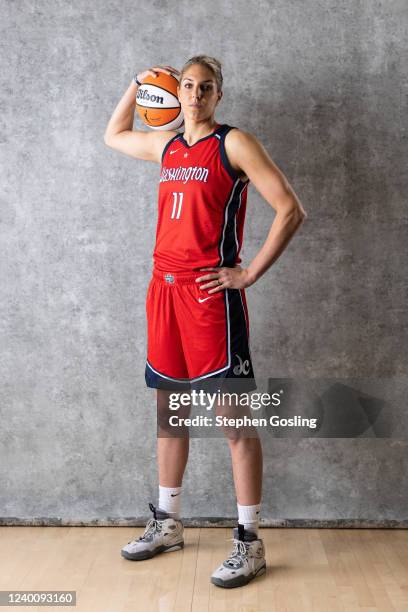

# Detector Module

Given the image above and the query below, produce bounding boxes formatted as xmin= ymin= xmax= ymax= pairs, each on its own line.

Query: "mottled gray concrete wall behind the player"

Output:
xmin=0 ymin=0 xmax=408 ymax=524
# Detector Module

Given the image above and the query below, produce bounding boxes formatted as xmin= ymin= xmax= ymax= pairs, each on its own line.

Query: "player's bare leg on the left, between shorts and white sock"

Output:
xmin=157 ymin=389 xmax=190 ymax=487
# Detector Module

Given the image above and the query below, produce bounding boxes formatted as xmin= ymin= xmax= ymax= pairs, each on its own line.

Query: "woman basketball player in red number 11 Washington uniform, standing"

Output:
xmin=105 ymin=55 xmax=306 ymax=588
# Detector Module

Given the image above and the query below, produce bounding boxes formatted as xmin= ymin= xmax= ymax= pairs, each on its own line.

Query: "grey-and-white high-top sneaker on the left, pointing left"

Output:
xmin=121 ymin=504 xmax=184 ymax=561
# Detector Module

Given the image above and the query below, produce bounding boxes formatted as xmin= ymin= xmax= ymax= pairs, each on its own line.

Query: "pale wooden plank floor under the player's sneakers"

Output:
xmin=0 ymin=527 xmax=408 ymax=612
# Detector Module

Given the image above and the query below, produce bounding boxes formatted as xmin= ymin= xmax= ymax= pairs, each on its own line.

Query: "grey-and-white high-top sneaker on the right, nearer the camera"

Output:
xmin=211 ymin=524 xmax=266 ymax=589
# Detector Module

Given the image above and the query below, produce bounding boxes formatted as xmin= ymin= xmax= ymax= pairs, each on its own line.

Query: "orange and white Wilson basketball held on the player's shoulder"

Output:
xmin=136 ymin=72 xmax=184 ymax=130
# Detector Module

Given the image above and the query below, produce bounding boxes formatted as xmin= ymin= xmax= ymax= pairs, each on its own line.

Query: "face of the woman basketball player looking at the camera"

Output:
xmin=177 ymin=64 xmax=222 ymax=120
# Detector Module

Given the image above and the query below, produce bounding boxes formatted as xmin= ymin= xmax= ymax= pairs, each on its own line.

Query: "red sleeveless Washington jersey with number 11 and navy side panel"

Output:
xmin=153 ymin=123 xmax=249 ymax=272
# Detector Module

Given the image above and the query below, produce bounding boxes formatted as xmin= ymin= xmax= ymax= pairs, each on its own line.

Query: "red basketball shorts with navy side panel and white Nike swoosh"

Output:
xmin=145 ymin=269 xmax=256 ymax=391
